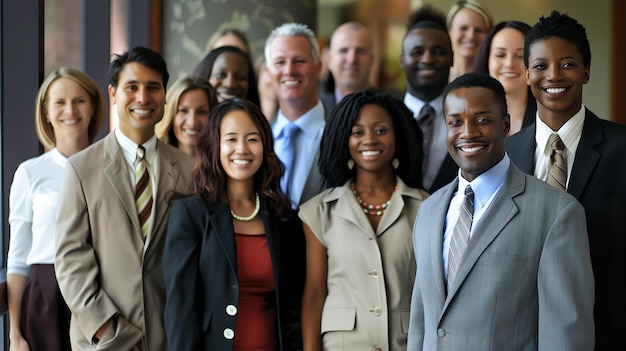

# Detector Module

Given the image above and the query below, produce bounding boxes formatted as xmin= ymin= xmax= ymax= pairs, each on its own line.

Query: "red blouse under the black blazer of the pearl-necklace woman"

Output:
xmin=233 ymin=234 xmax=278 ymax=351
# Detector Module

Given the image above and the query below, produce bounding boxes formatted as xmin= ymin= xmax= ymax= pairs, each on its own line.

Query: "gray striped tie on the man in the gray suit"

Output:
xmin=448 ymin=185 xmax=474 ymax=291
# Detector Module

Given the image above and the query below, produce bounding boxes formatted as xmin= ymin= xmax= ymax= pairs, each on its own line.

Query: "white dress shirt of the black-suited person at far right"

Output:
xmin=534 ymin=106 xmax=585 ymax=188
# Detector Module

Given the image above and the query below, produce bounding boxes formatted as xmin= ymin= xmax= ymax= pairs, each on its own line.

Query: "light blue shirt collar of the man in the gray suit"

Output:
xmin=457 ymin=153 xmax=511 ymax=207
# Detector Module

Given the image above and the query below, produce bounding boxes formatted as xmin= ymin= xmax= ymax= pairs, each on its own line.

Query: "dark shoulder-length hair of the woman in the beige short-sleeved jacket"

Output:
xmin=319 ymin=89 xmax=423 ymax=188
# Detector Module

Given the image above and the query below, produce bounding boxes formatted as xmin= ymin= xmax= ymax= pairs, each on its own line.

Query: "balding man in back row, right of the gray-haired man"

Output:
xmin=320 ymin=22 xmax=374 ymax=114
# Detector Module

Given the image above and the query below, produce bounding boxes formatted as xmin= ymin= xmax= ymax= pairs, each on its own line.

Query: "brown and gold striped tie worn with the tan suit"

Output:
xmin=135 ymin=145 xmax=153 ymax=240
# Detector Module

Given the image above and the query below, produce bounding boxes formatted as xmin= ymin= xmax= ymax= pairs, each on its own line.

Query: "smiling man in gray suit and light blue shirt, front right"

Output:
xmin=408 ymin=73 xmax=594 ymax=351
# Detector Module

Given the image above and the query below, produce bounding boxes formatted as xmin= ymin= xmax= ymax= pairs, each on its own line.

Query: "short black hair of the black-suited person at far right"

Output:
xmin=524 ymin=11 xmax=591 ymax=67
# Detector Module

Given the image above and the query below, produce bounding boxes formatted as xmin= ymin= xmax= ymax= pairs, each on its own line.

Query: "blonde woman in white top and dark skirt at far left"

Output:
xmin=7 ymin=67 xmax=104 ymax=350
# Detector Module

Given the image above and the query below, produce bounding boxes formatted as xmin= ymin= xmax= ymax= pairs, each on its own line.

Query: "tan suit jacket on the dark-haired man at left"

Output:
xmin=55 ymin=133 xmax=194 ymax=351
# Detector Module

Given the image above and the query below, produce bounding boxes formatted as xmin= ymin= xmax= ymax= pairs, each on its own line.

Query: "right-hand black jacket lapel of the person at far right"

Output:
xmin=567 ymin=110 xmax=604 ymax=199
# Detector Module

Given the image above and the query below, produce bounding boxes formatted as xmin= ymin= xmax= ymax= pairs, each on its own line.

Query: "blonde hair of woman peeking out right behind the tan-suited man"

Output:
xmin=154 ymin=76 xmax=217 ymax=147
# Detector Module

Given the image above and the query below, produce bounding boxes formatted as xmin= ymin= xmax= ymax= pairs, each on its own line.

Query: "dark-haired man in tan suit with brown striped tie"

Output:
xmin=55 ymin=47 xmax=193 ymax=351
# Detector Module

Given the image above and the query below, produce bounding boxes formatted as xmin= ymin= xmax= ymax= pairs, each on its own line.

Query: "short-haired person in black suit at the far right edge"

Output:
xmin=506 ymin=11 xmax=626 ymax=350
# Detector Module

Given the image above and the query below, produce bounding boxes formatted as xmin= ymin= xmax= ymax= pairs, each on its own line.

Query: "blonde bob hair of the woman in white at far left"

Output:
xmin=35 ymin=67 xmax=105 ymax=151
